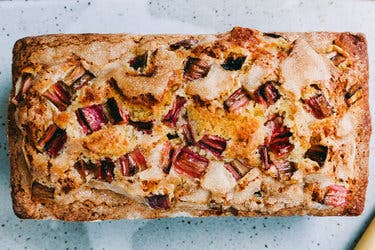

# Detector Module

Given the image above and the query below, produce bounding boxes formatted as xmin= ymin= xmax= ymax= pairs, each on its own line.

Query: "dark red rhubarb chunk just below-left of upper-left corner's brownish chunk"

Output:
xmin=43 ymin=81 xmax=71 ymax=111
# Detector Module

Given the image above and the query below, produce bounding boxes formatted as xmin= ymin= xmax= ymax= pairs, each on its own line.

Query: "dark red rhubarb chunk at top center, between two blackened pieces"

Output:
xmin=184 ymin=57 xmax=211 ymax=81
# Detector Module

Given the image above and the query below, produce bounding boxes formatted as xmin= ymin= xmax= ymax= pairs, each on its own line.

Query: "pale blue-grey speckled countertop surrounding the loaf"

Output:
xmin=0 ymin=0 xmax=375 ymax=249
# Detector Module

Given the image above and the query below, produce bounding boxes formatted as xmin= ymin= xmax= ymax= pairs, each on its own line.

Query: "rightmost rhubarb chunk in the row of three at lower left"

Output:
xmin=119 ymin=147 xmax=147 ymax=176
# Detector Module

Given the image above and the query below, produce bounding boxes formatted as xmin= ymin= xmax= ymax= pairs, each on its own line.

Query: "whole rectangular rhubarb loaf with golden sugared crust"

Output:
xmin=8 ymin=27 xmax=371 ymax=221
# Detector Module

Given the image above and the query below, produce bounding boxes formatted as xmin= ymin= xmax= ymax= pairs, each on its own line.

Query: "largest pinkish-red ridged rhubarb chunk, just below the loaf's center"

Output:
xmin=173 ymin=147 xmax=209 ymax=178
